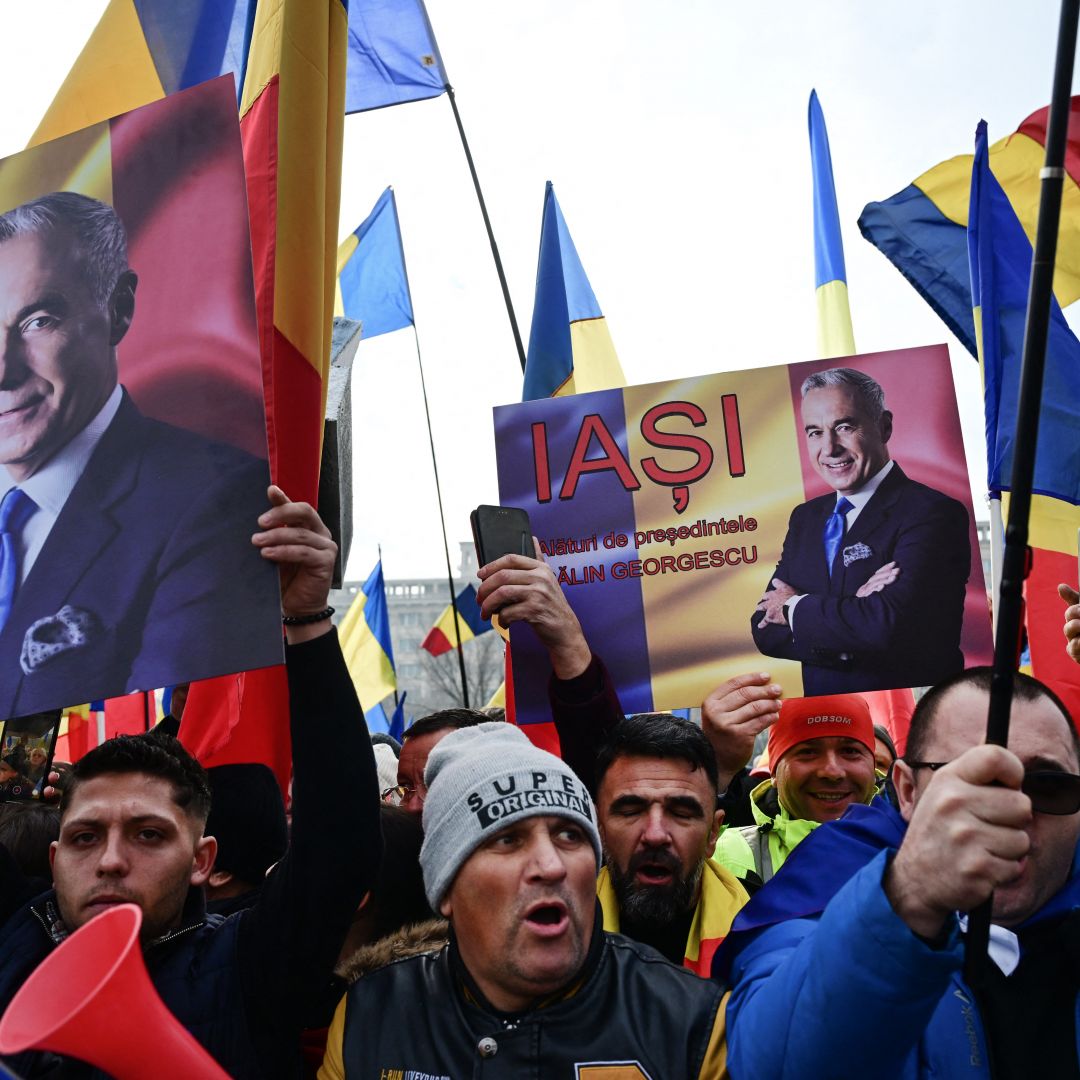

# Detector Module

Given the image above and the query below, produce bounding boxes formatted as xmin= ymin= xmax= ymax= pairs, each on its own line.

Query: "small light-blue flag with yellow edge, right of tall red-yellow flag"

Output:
xmin=335 ymin=188 xmax=413 ymax=341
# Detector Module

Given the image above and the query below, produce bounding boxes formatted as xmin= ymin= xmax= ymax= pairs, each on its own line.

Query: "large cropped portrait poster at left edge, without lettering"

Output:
xmin=0 ymin=78 xmax=282 ymax=718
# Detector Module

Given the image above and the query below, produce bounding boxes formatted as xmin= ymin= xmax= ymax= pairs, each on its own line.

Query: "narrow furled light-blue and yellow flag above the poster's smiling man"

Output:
xmin=808 ymin=90 xmax=855 ymax=357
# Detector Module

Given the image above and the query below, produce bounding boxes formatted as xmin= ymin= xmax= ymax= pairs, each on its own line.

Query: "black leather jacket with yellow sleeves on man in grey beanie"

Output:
xmin=319 ymin=918 xmax=726 ymax=1080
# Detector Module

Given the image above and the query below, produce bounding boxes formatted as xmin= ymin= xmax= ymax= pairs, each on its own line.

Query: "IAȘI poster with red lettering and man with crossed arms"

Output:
xmin=495 ymin=346 xmax=993 ymax=723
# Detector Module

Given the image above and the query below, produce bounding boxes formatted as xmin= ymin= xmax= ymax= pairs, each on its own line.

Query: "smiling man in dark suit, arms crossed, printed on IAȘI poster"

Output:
xmin=751 ymin=367 xmax=971 ymax=694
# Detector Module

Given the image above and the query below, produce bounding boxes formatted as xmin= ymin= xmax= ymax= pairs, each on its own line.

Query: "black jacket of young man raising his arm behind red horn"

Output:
xmin=0 ymin=633 xmax=382 ymax=1080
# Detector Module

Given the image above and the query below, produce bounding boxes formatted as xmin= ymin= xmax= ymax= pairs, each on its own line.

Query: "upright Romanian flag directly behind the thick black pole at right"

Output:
xmin=968 ymin=123 xmax=1080 ymax=716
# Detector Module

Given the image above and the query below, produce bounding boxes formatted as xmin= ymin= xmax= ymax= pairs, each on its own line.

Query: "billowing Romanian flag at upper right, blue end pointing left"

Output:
xmin=859 ymin=97 xmax=1080 ymax=355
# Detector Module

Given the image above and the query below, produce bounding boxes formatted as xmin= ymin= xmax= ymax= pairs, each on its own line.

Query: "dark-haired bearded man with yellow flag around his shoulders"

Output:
xmin=596 ymin=713 xmax=747 ymax=975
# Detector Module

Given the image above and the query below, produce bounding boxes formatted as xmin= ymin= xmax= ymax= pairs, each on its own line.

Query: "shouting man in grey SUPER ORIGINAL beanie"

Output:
xmin=319 ymin=724 xmax=725 ymax=1080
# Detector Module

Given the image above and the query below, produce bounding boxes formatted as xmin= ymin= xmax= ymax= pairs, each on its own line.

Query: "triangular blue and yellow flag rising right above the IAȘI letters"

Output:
xmin=522 ymin=180 xmax=626 ymax=401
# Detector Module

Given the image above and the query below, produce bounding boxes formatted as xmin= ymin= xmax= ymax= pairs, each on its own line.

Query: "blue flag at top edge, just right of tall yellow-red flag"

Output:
xmin=346 ymin=0 xmax=446 ymax=112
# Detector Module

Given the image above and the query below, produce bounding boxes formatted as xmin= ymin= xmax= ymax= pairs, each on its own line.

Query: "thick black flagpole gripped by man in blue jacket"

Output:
xmin=964 ymin=0 xmax=1080 ymax=989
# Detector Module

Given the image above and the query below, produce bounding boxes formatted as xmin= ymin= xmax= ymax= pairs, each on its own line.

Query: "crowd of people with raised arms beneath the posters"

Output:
xmin=0 ymin=477 xmax=1080 ymax=1078
